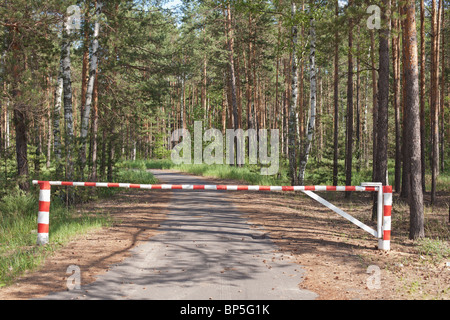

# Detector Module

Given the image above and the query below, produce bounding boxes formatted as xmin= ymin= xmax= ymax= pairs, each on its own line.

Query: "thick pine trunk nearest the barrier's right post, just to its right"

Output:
xmin=403 ymin=0 xmax=425 ymax=239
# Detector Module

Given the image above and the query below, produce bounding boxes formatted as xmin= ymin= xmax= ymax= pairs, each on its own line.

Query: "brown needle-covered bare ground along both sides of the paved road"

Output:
xmin=0 ymin=170 xmax=450 ymax=300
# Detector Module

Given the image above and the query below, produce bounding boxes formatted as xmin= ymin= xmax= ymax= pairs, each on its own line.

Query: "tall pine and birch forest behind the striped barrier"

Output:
xmin=0 ymin=0 xmax=450 ymax=239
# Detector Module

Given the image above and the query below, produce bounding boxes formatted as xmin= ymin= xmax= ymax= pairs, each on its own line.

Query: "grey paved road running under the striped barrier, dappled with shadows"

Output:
xmin=41 ymin=170 xmax=317 ymax=300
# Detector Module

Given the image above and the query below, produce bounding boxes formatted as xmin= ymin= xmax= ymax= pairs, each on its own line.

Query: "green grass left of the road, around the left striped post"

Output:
xmin=0 ymin=168 xmax=156 ymax=287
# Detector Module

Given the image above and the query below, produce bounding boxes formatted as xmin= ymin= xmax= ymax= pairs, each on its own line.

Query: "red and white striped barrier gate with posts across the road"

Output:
xmin=33 ymin=180 xmax=392 ymax=250
